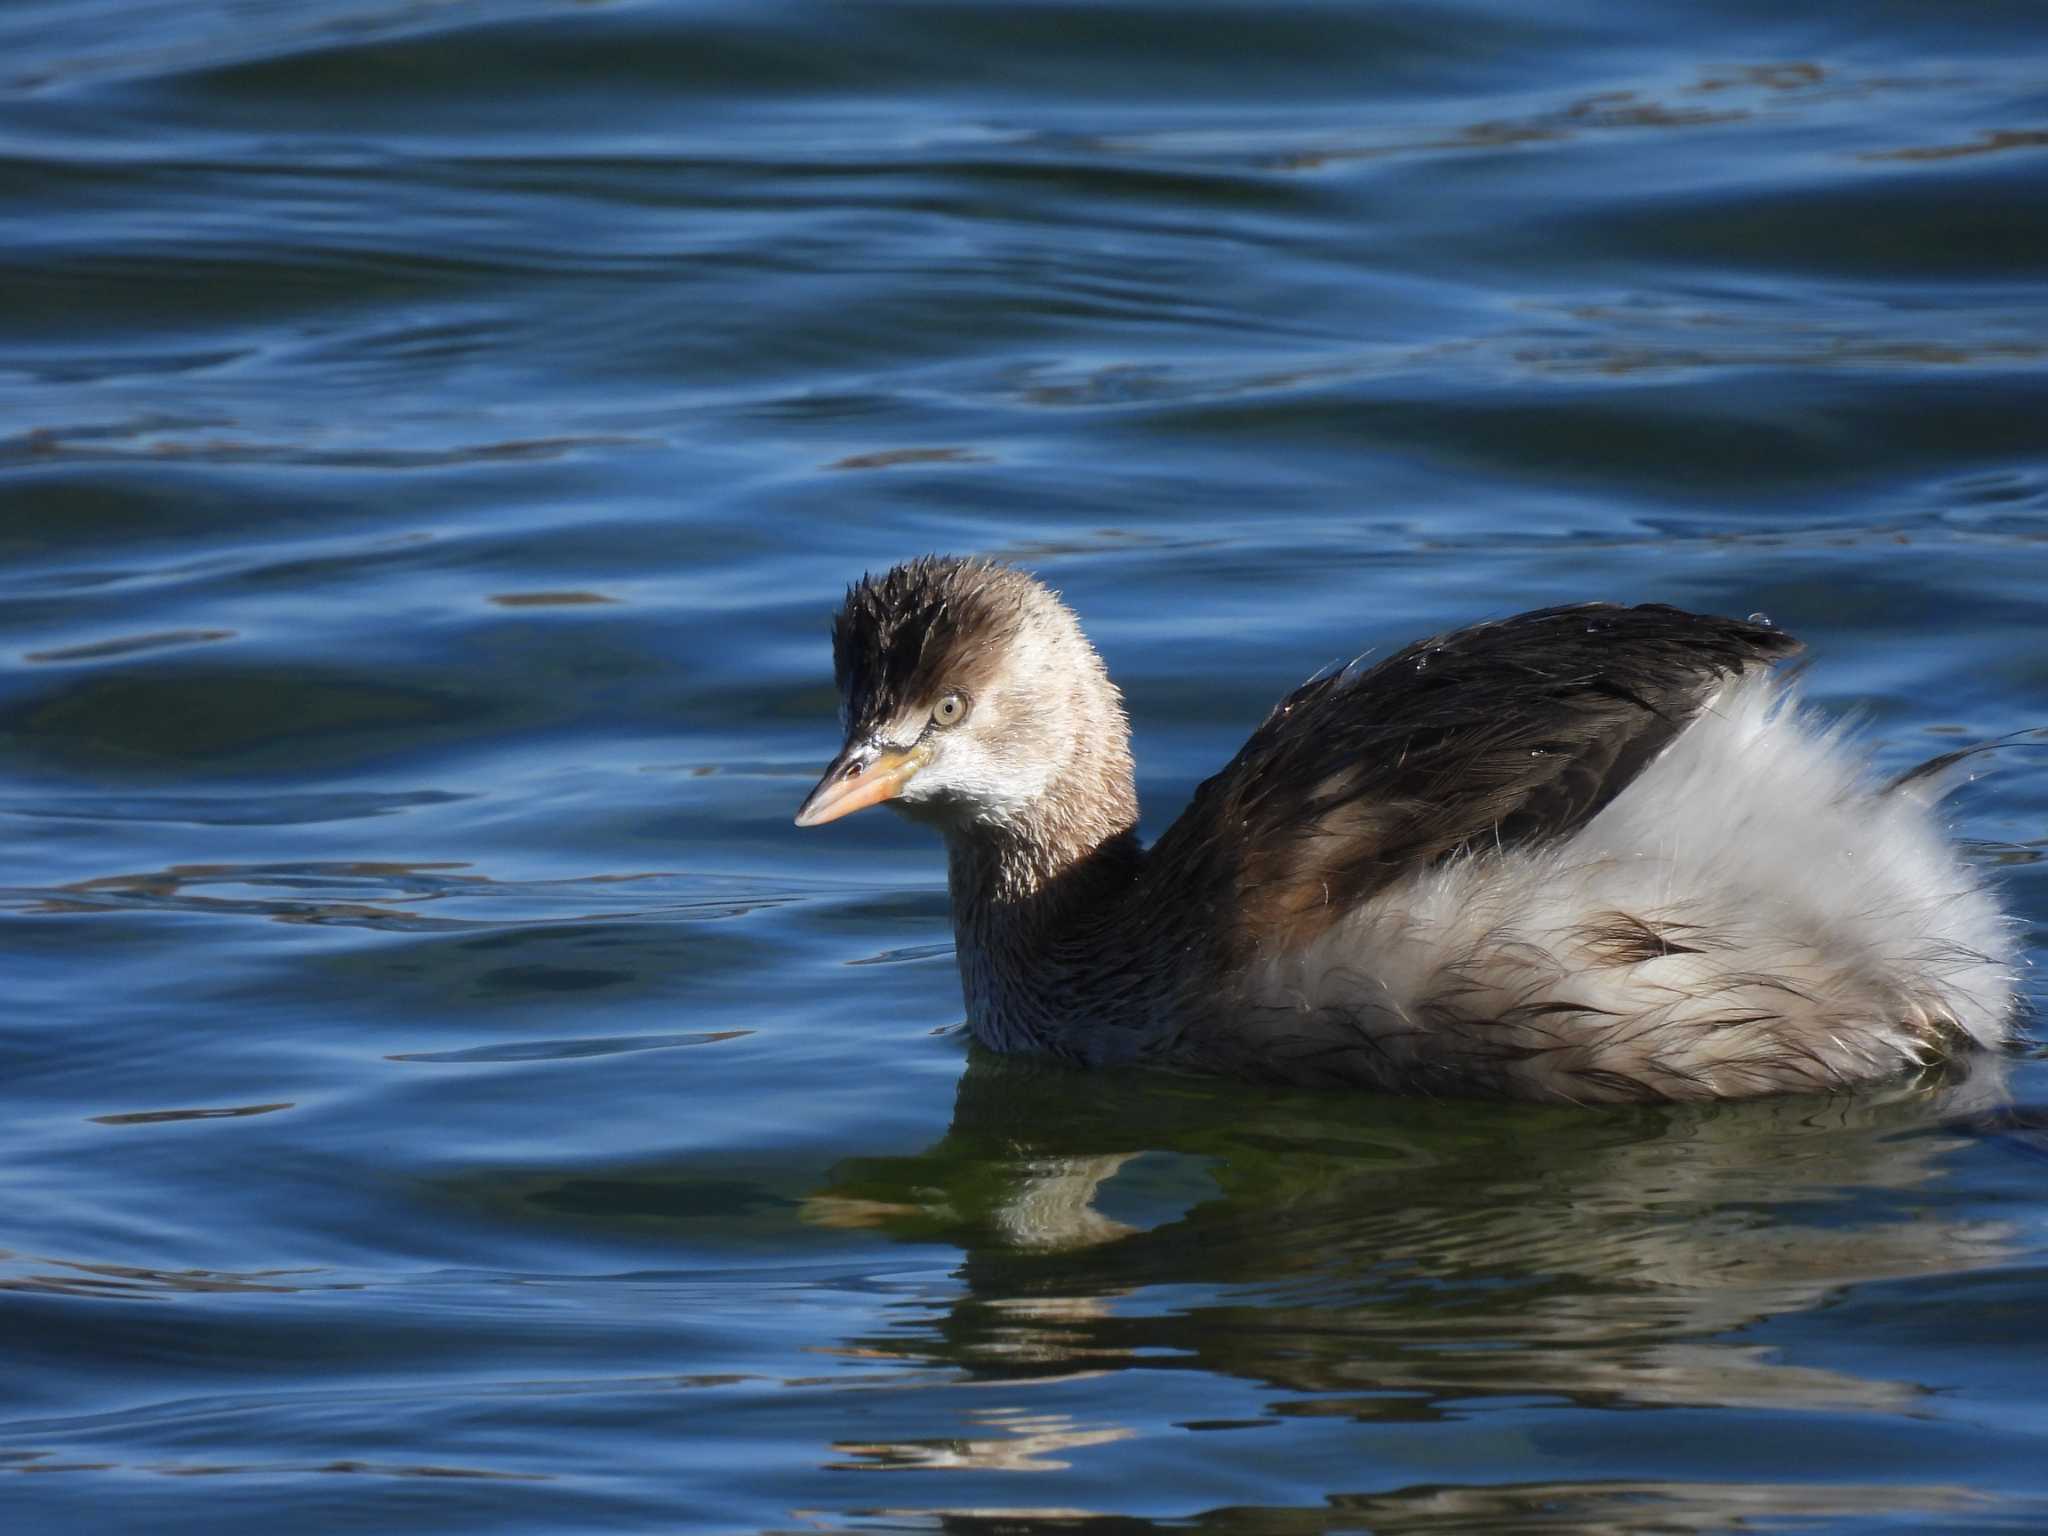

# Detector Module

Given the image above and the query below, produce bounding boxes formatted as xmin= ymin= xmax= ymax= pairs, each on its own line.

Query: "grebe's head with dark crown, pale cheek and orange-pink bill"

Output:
xmin=797 ymin=557 xmax=1137 ymax=838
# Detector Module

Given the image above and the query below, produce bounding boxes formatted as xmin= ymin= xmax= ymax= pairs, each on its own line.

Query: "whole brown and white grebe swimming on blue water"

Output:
xmin=797 ymin=557 xmax=2013 ymax=1102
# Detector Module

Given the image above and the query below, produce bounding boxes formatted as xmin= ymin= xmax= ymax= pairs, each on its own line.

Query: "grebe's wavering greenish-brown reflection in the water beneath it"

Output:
xmin=805 ymin=1051 xmax=2013 ymax=1433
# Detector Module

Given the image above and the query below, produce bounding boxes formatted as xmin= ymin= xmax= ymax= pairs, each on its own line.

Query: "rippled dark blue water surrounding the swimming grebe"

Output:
xmin=0 ymin=0 xmax=2048 ymax=1536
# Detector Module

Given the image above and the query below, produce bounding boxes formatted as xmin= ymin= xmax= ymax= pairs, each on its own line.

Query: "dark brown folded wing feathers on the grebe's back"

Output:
xmin=1151 ymin=604 xmax=1798 ymax=958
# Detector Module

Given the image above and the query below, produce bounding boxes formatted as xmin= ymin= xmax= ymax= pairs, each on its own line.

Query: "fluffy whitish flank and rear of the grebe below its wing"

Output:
xmin=1247 ymin=674 xmax=2015 ymax=1102
